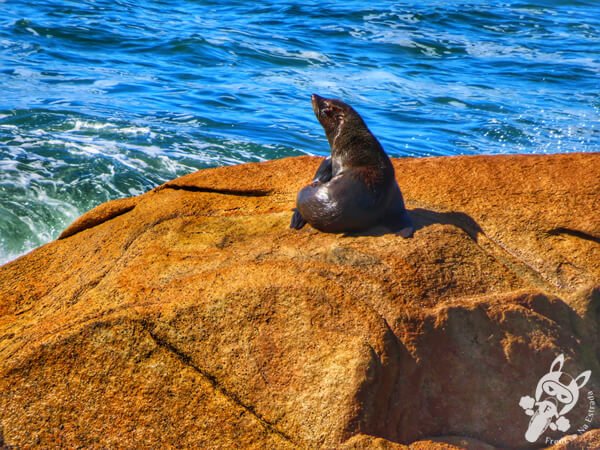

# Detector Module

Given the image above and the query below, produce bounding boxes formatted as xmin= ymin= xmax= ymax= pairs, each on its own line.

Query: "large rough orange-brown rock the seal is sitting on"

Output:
xmin=0 ymin=154 xmax=600 ymax=449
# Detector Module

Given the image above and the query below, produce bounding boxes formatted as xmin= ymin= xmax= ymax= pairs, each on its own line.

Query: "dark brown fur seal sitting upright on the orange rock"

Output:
xmin=290 ymin=94 xmax=414 ymax=237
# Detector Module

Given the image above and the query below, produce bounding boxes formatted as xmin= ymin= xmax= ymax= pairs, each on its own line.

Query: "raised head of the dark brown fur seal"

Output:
xmin=311 ymin=94 xmax=366 ymax=145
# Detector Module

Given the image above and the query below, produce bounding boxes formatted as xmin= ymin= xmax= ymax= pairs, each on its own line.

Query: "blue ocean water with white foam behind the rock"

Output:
xmin=0 ymin=0 xmax=600 ymax=263
